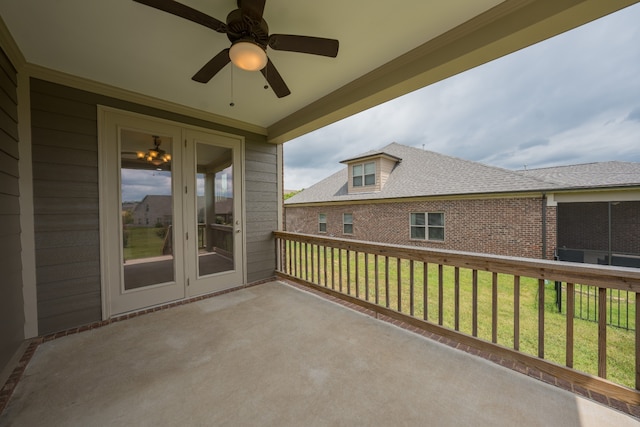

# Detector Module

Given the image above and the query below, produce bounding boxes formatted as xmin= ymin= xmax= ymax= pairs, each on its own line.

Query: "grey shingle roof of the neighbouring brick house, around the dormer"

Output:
xmin=285 ymin=142 xmax=640 ymax=205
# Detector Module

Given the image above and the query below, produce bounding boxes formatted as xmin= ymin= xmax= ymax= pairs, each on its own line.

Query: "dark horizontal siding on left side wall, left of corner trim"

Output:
xmin=0 ymin=45 xmax=24 ymax=371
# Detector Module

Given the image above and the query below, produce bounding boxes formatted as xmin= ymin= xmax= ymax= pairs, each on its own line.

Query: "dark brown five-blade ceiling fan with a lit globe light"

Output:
xmin=133 ymin=0 xmax=339 ymax=98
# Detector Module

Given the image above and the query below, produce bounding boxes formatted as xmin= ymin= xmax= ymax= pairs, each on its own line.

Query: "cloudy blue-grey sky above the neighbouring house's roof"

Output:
xmin=284 ymin=5 xmax=640 ymax=190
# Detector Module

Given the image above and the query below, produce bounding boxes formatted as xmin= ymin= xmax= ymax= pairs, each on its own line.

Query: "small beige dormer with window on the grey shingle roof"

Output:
xmin=340 ymin=152 xmax=402 ymax=194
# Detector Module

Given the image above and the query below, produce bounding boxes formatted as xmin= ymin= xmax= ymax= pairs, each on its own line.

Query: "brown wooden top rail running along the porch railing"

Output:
xmin=274 ymin=231 xmax=640 ymax=292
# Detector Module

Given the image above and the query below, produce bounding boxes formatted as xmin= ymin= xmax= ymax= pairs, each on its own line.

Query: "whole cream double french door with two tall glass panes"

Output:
xmin=100 ymin=108 xmax=244 ymax=318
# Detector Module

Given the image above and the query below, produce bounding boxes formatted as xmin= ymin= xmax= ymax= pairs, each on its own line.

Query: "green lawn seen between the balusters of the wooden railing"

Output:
xmin=288 ymin=250 xmax=635 ymax=388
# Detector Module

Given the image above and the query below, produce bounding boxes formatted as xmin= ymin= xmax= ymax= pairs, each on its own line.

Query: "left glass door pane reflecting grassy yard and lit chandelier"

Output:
xmin=120 ymin=130 xmax=175 ymax=290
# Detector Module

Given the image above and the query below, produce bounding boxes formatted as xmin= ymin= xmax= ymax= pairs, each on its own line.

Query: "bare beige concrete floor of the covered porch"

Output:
xmin=0 ymin=282 xmax=638 ymax=427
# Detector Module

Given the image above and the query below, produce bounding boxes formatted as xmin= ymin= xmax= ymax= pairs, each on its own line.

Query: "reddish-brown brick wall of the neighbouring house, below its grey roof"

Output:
xmin=286 ymin=198 xmax=556 ymax=259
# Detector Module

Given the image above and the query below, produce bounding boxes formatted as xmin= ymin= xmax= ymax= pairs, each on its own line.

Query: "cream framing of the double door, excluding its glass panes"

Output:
xmin=98 ymin=106 xmax=246 ymax=320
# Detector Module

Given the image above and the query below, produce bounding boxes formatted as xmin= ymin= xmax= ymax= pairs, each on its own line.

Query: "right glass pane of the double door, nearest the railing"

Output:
xmin=196 ymin=143 xmax=235 ymax=277
